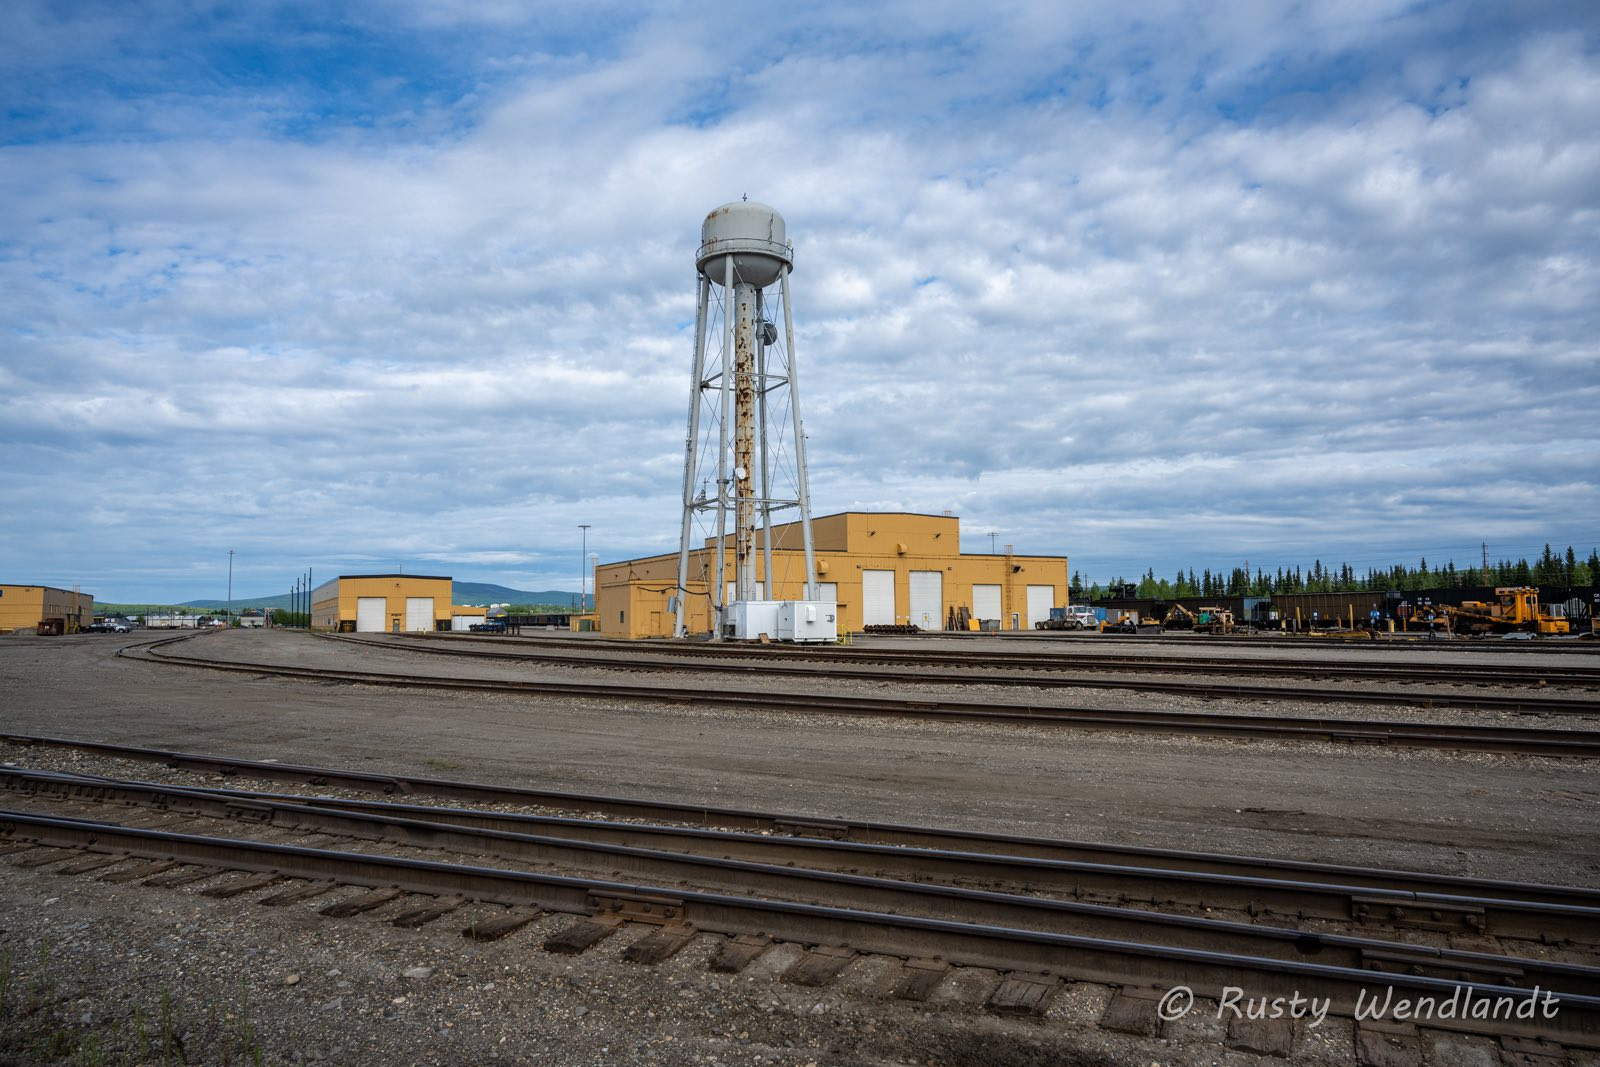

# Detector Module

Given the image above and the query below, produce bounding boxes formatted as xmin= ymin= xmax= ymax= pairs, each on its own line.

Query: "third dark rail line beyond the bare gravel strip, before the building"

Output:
xmin=393 ymin=633 xmax=1600 ymax=688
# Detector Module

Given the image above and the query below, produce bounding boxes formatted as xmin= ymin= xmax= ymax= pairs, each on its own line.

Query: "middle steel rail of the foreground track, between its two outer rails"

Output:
xmin=9 ymin=768 xmax=1600 ymax=953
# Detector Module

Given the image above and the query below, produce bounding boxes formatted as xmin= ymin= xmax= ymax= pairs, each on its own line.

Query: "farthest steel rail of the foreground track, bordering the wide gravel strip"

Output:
xmin=0 ymin=734 xmax=1600 ymax=907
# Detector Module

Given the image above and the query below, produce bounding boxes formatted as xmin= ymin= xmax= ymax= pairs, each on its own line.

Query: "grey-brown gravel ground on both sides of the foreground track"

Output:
xmin=0 ymin=632 xmax=1600 ymax=1064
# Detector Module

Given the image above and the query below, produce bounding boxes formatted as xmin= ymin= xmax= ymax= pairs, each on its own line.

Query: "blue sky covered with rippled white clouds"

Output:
xmin=0 ymin=0 xmax=1600 ymax=601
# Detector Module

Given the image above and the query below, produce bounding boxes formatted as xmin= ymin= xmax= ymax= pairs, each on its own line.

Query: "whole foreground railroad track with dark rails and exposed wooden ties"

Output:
xmin=0 ymin=755 xmax=1600 ymax=1046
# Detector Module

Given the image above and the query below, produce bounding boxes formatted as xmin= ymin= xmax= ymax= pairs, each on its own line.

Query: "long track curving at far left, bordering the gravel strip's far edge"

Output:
xmin=118 ymin=635 xmax=1600 ymax=758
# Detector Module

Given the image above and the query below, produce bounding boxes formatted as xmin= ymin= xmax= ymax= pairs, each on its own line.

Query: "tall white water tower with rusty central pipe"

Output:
xmin=674 ymin=200 xmax=832 ymax=640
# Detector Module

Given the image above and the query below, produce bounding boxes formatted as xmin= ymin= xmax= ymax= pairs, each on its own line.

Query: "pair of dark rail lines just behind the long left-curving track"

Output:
xmin=334 ymin=633 xmax=1600 ymax=703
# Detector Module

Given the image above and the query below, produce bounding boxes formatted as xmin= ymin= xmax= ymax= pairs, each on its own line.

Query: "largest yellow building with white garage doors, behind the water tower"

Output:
xmin=595 ymin=512 xmax=1067 ymax=637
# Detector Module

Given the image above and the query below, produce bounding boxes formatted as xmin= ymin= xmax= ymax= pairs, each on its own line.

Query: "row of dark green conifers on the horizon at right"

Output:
xmin=1072 ymin=544 xmax=1600 ymax=600
